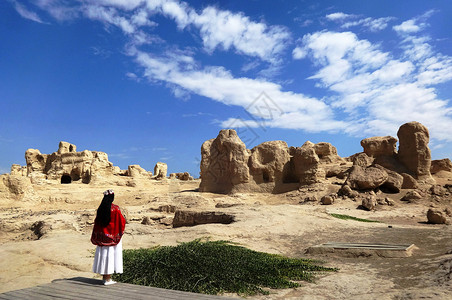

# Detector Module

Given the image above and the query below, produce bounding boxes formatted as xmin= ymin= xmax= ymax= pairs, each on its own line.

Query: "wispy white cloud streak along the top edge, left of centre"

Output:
xmin=14 ymin=0 xmax=290 ymax=64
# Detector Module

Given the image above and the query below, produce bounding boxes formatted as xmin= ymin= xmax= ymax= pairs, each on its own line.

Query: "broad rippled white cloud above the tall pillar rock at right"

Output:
xmin=294 ymin=31 xmax=452 ymax=141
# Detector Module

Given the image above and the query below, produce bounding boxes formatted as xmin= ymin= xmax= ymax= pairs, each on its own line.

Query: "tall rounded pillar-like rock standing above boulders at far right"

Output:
xmin=397 ymin=122 xmax=433 ymax=182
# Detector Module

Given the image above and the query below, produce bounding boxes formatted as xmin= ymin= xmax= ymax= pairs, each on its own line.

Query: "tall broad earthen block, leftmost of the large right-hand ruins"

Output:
xmin=199 ymin=129 xmax=250 ymax=193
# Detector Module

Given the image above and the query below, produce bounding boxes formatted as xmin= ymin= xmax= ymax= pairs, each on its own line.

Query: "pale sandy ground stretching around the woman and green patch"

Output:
xmin=0 ymin=180 xmax=452 ymax=299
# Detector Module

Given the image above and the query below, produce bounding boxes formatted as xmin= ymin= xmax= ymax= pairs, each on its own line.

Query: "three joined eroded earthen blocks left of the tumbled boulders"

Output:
xmin=200 ymin=129 xmax=346 ymax=193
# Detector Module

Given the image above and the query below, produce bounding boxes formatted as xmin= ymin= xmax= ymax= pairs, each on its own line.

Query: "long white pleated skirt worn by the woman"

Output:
xmin=93 ymin=239 xmax=122 ymax=275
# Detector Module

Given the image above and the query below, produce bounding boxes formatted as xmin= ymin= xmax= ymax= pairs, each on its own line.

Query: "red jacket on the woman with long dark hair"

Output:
xmin=91 ymin=204 xmax=126 ymax=246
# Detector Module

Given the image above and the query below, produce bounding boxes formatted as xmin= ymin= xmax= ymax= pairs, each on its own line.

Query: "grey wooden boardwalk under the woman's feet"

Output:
xmin=0 ymin=277 xmax=237 ymax=300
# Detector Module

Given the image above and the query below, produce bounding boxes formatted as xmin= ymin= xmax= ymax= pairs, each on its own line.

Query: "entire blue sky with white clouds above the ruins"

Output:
xmin=0 ymin=0 xmax=452 ymax=176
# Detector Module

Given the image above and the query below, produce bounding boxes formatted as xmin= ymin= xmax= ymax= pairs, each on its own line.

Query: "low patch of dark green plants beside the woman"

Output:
xmin=113 ymin=240 xmax=337 ymax=295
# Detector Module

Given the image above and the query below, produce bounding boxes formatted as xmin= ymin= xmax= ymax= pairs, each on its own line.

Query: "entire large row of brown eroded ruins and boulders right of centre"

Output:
xmin=200 ymin=122 xmax=444 ymax=193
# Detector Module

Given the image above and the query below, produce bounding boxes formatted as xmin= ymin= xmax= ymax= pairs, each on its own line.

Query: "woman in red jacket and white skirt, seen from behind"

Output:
xmin=91 ymin=190 xmax=126 ymax=285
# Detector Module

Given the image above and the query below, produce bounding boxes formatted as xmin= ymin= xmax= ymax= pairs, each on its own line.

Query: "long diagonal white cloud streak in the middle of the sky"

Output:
xmin=136 ymin=51 xmax=345 ymax=132
